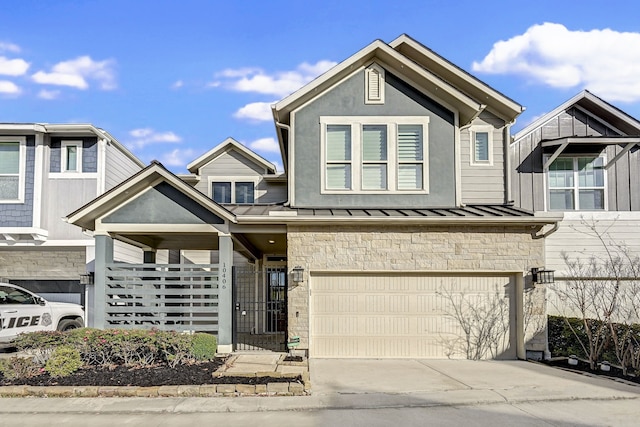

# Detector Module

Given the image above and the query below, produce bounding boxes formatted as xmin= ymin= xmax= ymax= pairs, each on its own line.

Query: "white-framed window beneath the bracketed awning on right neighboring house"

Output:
xmin=548 ymin=156 xmax=606 ymax=211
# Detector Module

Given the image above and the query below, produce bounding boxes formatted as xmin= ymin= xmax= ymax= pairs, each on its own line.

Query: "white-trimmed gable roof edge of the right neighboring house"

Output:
xmin=513 ymin=90 xmax=640 ymax=144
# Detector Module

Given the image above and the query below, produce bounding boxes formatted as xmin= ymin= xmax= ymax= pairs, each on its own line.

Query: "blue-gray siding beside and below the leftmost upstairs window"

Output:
xmin=0 ymin=135 xmax=36 ymax=227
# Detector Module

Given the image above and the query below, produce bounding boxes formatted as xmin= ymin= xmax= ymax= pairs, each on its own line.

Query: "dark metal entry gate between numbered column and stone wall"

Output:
xmin=233 ymin=266 xmax=287 ymax=351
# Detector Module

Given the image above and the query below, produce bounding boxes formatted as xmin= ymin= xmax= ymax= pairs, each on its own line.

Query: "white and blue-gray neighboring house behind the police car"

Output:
xmin=0 ymin=123 xmax=144 ymax=303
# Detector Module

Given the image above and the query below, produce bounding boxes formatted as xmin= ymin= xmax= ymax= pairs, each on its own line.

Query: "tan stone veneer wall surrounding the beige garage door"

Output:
xmin=287 ymin=225 xmax=546 ymax=351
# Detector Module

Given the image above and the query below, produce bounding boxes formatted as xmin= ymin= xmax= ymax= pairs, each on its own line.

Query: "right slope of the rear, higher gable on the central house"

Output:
xmin=389 ymin=34 xmax=525 ymax=122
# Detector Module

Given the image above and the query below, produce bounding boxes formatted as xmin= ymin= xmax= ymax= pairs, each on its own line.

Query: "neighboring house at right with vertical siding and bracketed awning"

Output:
xmin=510 ymin=91 xmax=640 ymax=320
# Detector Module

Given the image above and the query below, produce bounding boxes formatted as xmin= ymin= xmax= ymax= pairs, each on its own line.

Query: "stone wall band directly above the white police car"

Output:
xmin=0 ymin=247 xmax=86 ymax=280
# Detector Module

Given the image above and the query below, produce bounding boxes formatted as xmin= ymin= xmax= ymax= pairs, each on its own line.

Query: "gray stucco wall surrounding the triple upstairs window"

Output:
xmin=293 ymin=70 xmax=456 ymax=208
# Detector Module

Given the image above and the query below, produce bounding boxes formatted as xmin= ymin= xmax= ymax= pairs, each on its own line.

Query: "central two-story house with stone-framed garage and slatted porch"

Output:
xmin=67 ymin=35 xmax=562 ymax=358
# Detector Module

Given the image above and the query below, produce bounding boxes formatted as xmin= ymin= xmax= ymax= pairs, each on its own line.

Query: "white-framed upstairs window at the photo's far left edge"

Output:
xmin=0 ymin=137 xmax=26 ymax=203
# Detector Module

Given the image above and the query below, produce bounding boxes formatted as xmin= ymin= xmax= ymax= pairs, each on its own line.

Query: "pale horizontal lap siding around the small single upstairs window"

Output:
xmin=460 ymin=112 xmax=505 ymax=203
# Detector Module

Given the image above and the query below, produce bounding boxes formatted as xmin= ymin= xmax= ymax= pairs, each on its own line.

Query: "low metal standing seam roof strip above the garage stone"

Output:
xmin=223 ymin=204 xmax=534 ymax=219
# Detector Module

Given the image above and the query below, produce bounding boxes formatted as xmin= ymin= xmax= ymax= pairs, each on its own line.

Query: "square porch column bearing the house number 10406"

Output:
xmin=218 ymin=233 xmax=233 ymax=353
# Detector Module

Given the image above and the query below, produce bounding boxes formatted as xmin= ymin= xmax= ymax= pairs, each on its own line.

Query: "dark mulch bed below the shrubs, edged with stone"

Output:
xmin=0 ymin=358 xmax=298 ymax=387
